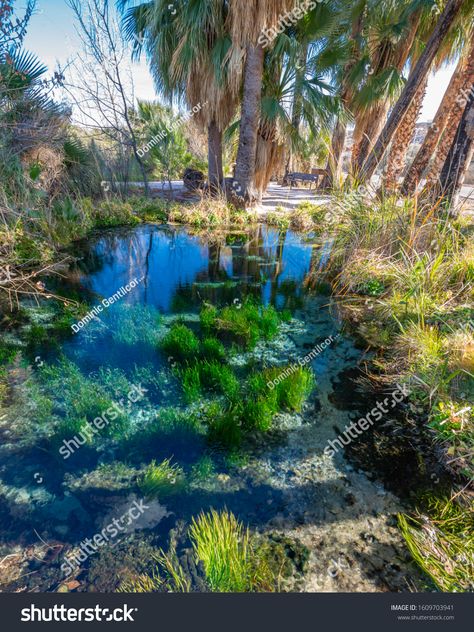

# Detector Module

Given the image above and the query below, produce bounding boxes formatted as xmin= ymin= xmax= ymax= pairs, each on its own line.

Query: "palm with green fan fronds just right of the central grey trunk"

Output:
xmin=255 ymin=5 xmax=339 ymax=195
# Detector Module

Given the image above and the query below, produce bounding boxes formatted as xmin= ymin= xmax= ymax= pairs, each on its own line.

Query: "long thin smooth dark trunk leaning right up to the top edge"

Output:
xmin=361 ymin=0 xmax=464 ymax=180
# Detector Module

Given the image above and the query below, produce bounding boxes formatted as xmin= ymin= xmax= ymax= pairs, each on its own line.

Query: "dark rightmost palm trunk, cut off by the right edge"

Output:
xmin=440 ymin=91 xmax=474 ymax=209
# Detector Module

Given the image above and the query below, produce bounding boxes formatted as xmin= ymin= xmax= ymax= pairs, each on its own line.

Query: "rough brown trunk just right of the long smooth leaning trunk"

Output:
xmin=383 ymin=75 xmax=428 ymax=191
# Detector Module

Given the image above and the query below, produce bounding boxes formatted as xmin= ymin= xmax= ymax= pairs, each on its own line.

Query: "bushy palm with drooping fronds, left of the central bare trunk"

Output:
xmin=120 ymin=0 xmax=241 ymax=190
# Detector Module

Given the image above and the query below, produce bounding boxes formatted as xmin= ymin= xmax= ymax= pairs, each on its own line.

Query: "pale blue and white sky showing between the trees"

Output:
xmin=23 ymin=0 xmax=453 ymax=121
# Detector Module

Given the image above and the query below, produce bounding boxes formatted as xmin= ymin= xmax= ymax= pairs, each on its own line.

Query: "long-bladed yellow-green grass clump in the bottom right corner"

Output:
xmin=398 ymin=499 xmax=474 ymax=592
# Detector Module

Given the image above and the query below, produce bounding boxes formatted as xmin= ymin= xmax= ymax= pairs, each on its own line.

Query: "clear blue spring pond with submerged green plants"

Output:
xmin=0 ymin=225 xmax=441 ymax=592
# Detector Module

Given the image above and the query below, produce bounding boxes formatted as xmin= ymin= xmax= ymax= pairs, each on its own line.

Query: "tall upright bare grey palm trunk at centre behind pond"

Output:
xmin=233 ymin=44 xmax=265 ymax=206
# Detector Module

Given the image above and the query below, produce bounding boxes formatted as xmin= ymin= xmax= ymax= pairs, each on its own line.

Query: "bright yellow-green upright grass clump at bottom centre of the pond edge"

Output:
xmin=189 ymin=509 xmax=275 ymax=592
